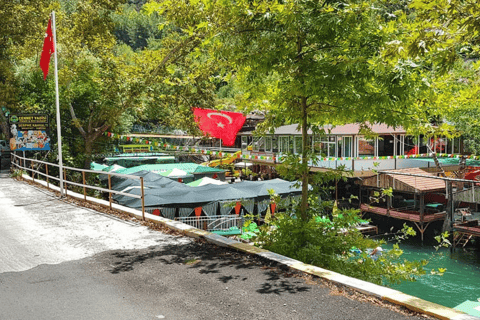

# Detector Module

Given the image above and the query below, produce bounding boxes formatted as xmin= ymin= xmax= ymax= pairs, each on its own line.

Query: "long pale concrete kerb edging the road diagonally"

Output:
xmin=17 ymin=175 xmax=480 ymax=320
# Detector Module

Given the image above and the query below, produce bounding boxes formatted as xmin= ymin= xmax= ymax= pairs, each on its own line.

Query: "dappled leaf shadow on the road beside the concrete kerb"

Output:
xmin=108 ymin=241 xmax=310 ymax=295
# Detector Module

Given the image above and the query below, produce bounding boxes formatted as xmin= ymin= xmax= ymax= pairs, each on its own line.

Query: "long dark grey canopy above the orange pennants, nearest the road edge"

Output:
xmin=114 ymin=179 xmax=301 ymax=208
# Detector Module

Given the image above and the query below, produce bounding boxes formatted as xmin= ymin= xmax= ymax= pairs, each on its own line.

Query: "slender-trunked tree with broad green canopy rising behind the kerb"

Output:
xmin=148 ymin=0 xmax=436 ymax=218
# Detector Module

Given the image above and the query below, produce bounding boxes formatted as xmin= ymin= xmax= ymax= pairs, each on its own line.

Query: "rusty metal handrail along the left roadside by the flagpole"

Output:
xmin=11 ymin=152 xmax=145 ymax=220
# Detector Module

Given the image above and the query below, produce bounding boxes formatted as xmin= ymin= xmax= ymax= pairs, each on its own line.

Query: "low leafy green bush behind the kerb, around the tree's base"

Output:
xmin=255 ymin=209 xmax=427 ymax=284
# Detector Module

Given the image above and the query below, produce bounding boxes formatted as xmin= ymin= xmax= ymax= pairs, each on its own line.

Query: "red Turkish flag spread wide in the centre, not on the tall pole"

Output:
xmin=193 ymin=108 xmax=246 ymax=146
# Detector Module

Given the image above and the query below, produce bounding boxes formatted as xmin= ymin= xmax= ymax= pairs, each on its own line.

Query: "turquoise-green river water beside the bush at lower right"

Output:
xmin=392 ymin=243 xmax=480 ymax=308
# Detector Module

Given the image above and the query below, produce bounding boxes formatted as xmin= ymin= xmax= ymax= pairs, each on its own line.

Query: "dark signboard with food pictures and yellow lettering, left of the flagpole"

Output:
xmin=9 ymin=114 xmax=50 ymax=151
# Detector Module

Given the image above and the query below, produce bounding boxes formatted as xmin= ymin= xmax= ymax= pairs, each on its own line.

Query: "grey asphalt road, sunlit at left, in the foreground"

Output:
xmin=0 ymin=169 xmax=420 ymax=320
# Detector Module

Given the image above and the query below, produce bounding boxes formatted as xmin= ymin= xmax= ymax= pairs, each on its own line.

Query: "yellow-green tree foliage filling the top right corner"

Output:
xmin=392 ymin=0 xmax=480 ymax=153
